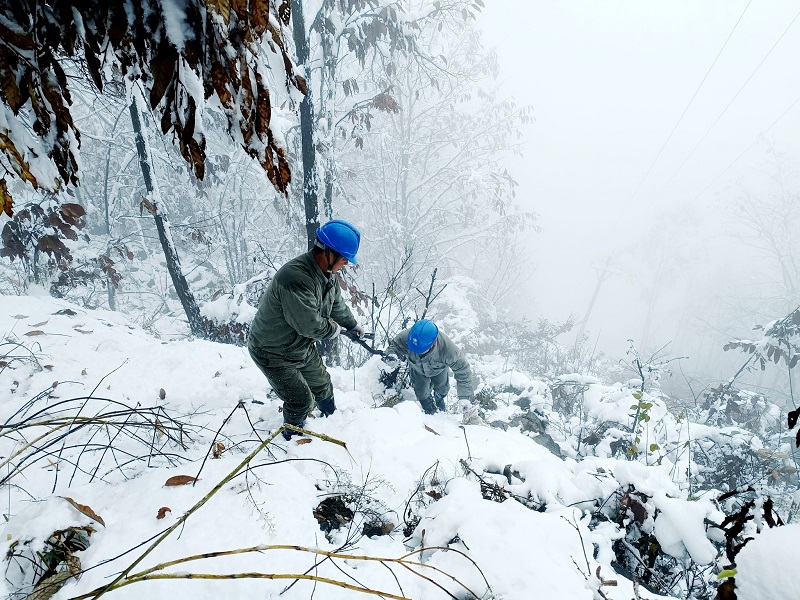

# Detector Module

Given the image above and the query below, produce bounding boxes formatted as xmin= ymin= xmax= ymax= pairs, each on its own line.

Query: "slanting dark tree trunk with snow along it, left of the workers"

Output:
xmin=130 ymin=92 xmax=205 ymax=337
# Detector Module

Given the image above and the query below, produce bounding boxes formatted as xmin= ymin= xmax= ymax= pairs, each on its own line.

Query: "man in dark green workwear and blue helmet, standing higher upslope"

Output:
xmin=247 ymin=219 xmax=364 ymax=441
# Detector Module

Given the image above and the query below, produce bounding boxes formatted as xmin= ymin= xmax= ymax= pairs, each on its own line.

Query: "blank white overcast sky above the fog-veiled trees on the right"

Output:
xmin=479 ymin=0 xmax=800 ymax=360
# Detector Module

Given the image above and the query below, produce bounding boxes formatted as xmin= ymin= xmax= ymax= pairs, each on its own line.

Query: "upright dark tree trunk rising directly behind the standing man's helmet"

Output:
xmin=291 ymin=0 xmax=319 ymax=250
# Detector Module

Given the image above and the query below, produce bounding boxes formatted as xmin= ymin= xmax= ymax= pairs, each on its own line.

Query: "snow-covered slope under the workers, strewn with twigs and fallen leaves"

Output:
xmin=0 ymin=297 xmax=790 ymax=600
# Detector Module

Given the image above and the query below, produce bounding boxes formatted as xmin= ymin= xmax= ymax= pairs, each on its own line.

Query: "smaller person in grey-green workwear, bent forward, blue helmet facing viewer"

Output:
xmin=384 ymin=319 xmax=475 ymax=415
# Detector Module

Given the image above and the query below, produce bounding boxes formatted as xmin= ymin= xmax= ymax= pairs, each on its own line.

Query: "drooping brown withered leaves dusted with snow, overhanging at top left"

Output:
xmin=0 ymin=0 xmax=305 ymax=216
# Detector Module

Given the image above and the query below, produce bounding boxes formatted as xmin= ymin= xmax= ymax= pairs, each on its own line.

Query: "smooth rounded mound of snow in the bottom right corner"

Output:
xmin=736 ymin=523 xmax=800 ymax=600
